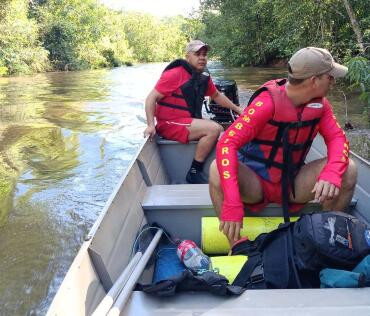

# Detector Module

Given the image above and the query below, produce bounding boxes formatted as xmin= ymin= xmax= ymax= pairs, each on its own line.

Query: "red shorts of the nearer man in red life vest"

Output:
xmin=246 ymin=173 xmax=305 ymax=213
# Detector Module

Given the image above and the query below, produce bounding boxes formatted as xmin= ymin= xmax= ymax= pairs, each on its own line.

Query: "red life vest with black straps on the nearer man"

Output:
xmin=239 ymin=79 xmax=322 ymax=222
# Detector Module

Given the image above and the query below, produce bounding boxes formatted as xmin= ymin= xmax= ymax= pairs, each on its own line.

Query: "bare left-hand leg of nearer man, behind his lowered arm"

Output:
xmin=209 ymin=160 xmax=263 ymax=246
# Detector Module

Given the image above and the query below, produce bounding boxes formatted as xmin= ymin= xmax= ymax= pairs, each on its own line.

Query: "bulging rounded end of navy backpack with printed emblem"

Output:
xmin=293 ymin=212 xmax=370 ymax=271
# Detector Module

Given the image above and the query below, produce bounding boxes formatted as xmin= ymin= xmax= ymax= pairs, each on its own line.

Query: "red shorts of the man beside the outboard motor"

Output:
xmin=156 ymin=117 xmax=193 ymax=144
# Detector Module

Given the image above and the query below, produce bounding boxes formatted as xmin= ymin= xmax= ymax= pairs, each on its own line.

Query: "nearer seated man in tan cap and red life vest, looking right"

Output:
xmin=210 ymin=47 xmax=357 ymax=245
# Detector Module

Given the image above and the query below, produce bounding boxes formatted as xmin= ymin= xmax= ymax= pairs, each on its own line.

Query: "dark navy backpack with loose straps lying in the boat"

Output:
xmin=232 ymin=212 xmax=370 ymax=289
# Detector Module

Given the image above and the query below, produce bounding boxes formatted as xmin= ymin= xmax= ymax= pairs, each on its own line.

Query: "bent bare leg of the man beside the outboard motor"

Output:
xmin=188 ymin=119 xmax=223 ymax=162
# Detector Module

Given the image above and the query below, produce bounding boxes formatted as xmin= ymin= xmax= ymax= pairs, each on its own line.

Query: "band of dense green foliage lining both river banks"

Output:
xmin=0 ymin=0 xmax=370 ymax=107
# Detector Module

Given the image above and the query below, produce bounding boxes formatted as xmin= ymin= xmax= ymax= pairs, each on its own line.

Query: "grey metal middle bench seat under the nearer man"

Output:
xmin=141 ymin=184 xmax=355 ymax=245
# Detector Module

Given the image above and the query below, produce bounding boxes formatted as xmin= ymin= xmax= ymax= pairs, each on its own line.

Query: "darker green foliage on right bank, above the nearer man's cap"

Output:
xmin=201 ymin=0 xmax=370 ymax=66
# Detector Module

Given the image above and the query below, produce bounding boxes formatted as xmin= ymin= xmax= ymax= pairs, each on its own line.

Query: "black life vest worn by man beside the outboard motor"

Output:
xmin=157 ymin=59 xmax=210 ymax=118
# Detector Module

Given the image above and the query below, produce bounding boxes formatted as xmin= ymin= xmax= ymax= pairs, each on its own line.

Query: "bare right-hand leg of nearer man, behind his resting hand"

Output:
xmin=290 ymin=158 xmax=357 ymax=211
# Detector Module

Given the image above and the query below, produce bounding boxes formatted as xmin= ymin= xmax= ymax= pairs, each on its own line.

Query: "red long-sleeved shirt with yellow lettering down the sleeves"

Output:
xmin=216 ymin=82 xmax=349 ymax=222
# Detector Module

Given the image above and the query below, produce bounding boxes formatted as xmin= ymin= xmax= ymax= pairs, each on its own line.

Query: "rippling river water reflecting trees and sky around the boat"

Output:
xmin=0 ymin=63 xmax=370 ymax=315
